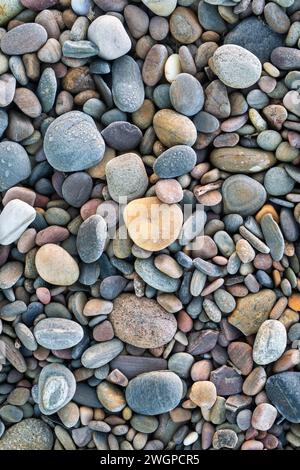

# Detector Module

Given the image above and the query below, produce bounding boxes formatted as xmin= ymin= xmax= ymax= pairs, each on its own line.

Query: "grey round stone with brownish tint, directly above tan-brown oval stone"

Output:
xmin=170 ymin=73 xmax=204 ymax=116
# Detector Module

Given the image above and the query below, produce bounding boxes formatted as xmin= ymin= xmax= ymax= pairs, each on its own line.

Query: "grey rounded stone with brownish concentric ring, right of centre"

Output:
xmin=222 ymin=175 xmax=267 ymax=217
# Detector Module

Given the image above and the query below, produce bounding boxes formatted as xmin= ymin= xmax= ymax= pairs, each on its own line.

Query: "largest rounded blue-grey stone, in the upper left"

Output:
xmin=44 ymin=111 xmax=105 ymax=172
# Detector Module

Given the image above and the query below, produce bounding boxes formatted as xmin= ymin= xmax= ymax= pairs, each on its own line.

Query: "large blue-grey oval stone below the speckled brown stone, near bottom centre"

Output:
xmin=126 ymin=371 xmax=183 ymax=416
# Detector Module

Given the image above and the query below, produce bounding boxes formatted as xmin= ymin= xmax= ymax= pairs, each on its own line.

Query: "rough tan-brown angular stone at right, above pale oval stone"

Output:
xmin=228 ymin=289 xmax=276 ymax=336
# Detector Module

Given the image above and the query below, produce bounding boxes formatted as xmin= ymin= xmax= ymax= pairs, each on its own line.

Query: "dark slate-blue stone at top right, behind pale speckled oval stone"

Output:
xmin=224 ymin=16 xmax=284 ymax=63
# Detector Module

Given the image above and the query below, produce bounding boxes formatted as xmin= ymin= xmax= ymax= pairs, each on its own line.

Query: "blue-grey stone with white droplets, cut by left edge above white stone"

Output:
xmin=0 ymin=141 xmax=31 ymax=192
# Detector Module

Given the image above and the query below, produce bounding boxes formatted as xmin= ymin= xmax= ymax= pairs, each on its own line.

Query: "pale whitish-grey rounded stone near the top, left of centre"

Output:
xmin=88 ymin=15 xmax=131 ymax=60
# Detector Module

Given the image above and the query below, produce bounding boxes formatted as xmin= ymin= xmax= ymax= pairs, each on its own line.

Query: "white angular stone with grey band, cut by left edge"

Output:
xmin=0 ymin=199 xmax=36 ymax=245
